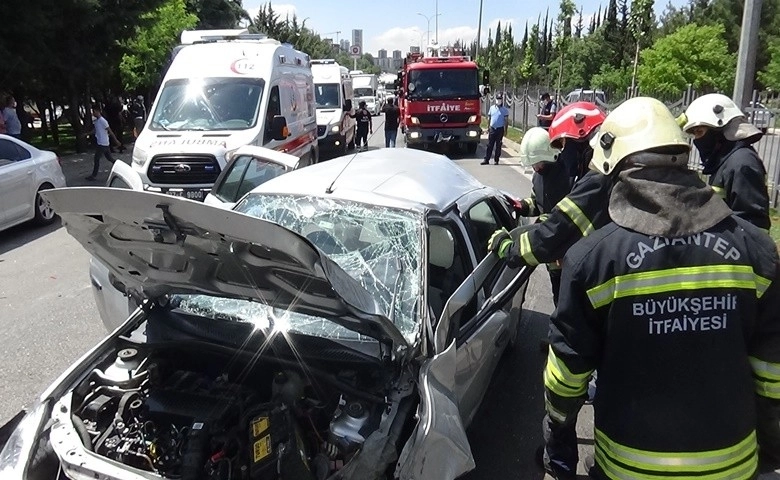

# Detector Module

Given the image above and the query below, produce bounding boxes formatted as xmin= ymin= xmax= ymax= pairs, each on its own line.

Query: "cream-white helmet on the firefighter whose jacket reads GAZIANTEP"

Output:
xmin=590 ymin=97 xmax=690 ymax=175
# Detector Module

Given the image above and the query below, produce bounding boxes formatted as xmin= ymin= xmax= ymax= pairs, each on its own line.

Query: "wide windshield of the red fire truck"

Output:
xmin=408 ymin=68 xmax=479 ymax=99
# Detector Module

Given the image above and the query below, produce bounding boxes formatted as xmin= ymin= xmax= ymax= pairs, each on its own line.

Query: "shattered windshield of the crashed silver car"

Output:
xmin=176 ymin=194 xmax=423 ymax=342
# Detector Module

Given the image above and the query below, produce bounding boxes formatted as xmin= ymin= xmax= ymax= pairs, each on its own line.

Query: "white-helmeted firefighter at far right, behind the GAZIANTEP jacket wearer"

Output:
xmin=683 ymin=93 xmax=770 ymax=230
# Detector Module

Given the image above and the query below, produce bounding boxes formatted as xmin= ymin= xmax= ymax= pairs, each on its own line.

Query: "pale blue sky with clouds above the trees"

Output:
xmin=243 ymin=0 xmax=687 ymax=56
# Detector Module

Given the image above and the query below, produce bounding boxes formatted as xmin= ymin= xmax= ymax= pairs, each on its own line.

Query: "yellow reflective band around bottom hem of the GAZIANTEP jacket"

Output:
xmin=595 ymin=429 xmax=758 ymax=480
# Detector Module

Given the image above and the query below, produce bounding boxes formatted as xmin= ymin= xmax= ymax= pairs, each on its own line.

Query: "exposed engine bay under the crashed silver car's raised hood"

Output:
xmin=52 ymin=342 xmax=414 ymax=480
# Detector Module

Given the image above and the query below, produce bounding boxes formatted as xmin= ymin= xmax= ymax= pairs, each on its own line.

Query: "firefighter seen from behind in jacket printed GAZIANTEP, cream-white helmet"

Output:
xmin=544 ymin=97 xmax=780 ymax=480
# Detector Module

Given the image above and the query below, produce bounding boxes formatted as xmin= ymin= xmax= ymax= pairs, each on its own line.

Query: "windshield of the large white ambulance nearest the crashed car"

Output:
xmin=150 ymin=78 xmax=265 ymax=130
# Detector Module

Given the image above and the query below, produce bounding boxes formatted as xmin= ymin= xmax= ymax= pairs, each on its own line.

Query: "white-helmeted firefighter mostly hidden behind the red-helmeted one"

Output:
xmin=517 ymin=127 xmax=570 ymax=305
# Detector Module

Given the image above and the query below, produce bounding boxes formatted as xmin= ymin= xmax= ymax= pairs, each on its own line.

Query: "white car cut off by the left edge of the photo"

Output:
xmin=0 ymin=135 xmax=65 ymax=231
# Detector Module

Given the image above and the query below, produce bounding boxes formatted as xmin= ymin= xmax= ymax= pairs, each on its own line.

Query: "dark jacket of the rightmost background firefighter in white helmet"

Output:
xmin=704 ymin=143 xmax=770 ymax=230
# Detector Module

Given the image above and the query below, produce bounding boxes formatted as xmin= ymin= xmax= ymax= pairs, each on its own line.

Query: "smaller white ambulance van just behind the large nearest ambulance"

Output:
xmin=311 ymin=59 xmax=357 ymax=155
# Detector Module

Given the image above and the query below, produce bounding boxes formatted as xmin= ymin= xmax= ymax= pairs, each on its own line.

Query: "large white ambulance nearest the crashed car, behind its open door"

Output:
xmin=132 ymin=30 xmax=319 ymax=200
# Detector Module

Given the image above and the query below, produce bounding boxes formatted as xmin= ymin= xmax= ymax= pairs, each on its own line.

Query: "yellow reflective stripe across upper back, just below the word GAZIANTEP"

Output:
xmin=587 ymin=265 xmax=771 ymax=308
